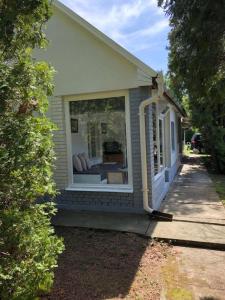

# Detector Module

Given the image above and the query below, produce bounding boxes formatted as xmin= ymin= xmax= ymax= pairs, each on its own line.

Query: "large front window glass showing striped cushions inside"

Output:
xmin=69 ymin=97 xmax=128 ymax=186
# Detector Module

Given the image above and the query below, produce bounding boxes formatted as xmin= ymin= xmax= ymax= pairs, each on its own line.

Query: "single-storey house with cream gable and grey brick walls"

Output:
xmin=37 ymin=1 xmax=185 ymax=213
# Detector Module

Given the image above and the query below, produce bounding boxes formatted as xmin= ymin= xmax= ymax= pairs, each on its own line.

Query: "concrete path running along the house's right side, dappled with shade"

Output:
xmin=147 ymin=155 xmax=225 ymax=250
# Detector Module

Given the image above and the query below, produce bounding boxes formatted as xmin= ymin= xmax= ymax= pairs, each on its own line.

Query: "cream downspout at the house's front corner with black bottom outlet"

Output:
xmin=139 ymin=75 xmax=173 ymax=221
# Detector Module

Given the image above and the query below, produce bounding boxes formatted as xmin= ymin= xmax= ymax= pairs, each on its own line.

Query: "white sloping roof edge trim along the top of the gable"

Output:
xmin=53 ymin=0 xmax=157 ymax=77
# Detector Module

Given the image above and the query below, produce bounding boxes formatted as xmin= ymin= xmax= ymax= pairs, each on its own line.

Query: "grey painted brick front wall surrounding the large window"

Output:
xmin=51 ymin=87 xmax=150 ymax=212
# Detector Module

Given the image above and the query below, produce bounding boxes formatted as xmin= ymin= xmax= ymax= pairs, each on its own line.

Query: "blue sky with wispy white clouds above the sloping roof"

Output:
xmin=60 ymin=0 xmax=169 ymax=72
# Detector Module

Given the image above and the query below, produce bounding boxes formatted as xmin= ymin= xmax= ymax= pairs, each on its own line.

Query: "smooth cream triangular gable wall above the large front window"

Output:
xmin=35 ymin=8 xmax=141 ymax=95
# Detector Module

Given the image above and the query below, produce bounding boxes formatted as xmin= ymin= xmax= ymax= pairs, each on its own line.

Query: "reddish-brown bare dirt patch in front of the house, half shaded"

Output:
xmin=41 ymin=227 xmax=173 ymax=300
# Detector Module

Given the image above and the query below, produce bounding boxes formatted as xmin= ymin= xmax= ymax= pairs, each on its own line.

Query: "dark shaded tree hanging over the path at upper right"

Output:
xmin=159 ymin=0 xmax=225 ymax=173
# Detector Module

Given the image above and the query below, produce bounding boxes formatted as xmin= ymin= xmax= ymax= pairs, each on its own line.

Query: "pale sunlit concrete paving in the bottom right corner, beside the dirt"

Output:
xmin=161 ymin=246 xmax=225 ymax=300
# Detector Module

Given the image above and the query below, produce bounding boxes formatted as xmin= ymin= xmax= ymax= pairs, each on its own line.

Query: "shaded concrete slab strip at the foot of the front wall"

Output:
xmin=52 ymin=209 xmax=149 ymax=235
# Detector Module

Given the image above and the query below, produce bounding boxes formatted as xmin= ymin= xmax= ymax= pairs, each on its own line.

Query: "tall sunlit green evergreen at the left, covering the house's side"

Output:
xmin=0 ymin=0 xmax=63 ymax=300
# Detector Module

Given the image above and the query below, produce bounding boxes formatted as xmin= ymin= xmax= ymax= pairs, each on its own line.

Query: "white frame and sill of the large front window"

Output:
xmin=63 ymin=90 xmax=133 ymax=193
